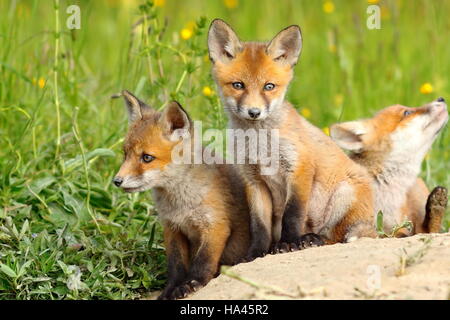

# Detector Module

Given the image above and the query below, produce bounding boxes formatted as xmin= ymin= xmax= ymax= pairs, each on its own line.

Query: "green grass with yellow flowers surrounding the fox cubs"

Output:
xmin=0 ymin=0 xmax=450 ymax=299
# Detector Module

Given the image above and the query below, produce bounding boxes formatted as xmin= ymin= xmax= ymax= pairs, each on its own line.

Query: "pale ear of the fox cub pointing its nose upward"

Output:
xmin=330 ymin=121 xmax=367 ymax=152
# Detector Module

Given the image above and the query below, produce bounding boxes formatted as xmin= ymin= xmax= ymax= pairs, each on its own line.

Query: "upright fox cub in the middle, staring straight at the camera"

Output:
xmin=208 ymin=19 xmax=376 ymax=259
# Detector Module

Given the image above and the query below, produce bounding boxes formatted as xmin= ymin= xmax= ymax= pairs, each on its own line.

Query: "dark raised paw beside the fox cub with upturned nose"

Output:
xmin=423 ymin=186 xmax=448 ymax=233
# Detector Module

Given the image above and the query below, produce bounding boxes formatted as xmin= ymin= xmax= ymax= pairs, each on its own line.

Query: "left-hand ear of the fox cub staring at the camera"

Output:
xmin=208 ymin=19 xmax=242 ymax=63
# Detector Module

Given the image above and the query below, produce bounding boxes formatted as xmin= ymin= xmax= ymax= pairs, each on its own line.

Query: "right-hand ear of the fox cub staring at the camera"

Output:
xmin=266 ymin=25 xmax=302 ymax=66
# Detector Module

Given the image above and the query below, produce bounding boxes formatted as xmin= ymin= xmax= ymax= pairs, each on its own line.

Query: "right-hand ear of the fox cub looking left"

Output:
xmin=160 ymin=101 xmax=192 ymax=141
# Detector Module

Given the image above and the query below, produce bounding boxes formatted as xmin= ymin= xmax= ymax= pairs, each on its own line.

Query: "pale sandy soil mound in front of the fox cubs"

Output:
xmin=190 ymin=233 xmax=450 ymax=299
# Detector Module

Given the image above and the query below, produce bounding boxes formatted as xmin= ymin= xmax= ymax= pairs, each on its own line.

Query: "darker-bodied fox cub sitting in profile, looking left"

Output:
xmin=114 ymin=91 xmax=250 ymax=299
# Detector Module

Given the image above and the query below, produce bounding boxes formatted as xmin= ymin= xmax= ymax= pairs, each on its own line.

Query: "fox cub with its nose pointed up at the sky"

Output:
xmin=330 ymin=98 xmax=448 ymax=235
